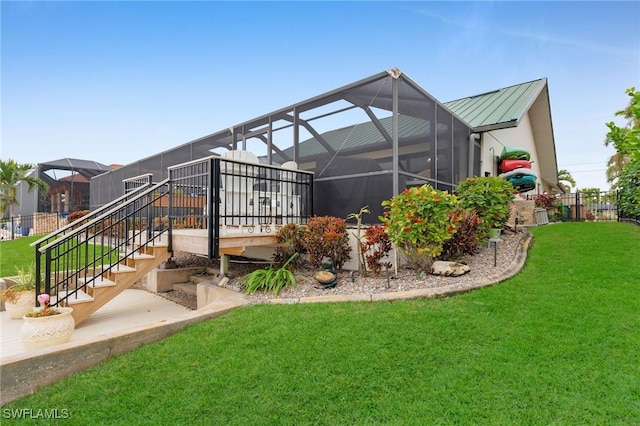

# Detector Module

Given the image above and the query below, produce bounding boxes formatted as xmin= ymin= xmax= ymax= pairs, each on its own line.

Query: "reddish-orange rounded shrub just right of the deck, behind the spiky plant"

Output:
xmin=302 ymin=216 xmax=351 ymax=269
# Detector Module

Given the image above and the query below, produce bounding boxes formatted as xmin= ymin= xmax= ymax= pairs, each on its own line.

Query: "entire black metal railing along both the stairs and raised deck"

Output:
xmin=32 ymin=156 xmax=313 ymax=305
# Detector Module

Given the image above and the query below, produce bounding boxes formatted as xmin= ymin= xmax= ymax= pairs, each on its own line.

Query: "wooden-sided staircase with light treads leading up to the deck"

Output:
xmin=52 ymin=243 xmax=171 ymax=325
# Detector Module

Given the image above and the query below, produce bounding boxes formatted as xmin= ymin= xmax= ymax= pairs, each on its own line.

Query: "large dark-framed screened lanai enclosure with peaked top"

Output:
xmin=91 ymin=69 xmax=480 ymax=223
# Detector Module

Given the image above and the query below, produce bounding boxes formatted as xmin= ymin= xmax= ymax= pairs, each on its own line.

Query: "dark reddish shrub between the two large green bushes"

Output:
xmin=440 ymin=208 xmax=482 ymax=260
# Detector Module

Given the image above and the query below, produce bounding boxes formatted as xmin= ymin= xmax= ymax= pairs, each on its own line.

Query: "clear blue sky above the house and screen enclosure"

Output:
xmin=0 ymin=1 xmax=640 ymax=189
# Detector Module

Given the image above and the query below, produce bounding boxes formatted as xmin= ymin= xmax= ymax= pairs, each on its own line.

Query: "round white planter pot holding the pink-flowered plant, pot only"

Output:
xmin=20 ymin=308 xmax=76 ymax=350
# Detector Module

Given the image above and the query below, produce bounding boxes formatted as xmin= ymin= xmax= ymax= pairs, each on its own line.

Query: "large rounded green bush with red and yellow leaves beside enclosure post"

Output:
xmin=379 ymin=185 xmax=458 ymax=271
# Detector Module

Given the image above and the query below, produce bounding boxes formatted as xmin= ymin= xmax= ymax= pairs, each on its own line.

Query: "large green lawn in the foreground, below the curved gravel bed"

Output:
xmin=3 ymin=223 xmax=640 ymax=425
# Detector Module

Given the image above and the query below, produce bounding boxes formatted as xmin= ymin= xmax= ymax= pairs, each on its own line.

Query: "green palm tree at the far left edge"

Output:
xmin=0 ymin=159 xmax=48 ymax=220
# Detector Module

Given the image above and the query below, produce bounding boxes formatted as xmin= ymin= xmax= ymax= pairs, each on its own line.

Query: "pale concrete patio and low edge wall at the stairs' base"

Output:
xmin=0 ymin=285 xmax=247 ymax=405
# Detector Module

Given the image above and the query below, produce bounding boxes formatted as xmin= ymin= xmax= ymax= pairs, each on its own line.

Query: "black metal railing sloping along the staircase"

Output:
xmin=35 ymin=180 xmax=171 ymax=305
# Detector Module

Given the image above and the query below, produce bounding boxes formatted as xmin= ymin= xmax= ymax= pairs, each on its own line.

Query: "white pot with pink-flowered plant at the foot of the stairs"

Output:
xmin=20 ymin=294 xmax=76 ymax=350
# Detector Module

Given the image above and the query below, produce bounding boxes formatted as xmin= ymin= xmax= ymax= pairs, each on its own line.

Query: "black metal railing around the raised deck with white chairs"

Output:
xmin=169 ymin=156 xmax=313 ymax=258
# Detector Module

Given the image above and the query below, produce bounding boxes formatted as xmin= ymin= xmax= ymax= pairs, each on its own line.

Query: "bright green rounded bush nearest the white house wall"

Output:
xmin=455 ymin=176 xmax=515 ymax=233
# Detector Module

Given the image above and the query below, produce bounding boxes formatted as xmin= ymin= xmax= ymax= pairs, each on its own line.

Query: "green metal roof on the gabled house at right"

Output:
xmin=444 ymin=78 xmax=547 ymax=132
